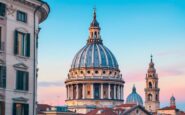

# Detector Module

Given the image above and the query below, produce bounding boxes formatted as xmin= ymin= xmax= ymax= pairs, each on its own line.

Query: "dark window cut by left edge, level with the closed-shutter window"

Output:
xmin=0 ymin=65 xmax=6 ymax=88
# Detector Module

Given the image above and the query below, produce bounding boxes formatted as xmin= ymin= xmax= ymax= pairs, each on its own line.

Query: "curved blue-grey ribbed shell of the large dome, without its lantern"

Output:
xmin=71 ymin=43 xmax=118 ymax=69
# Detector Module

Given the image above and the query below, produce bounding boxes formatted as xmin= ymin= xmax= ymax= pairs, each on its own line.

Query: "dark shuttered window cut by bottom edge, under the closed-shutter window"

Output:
xmin=13 ymin=103 xmax=29 ymax=115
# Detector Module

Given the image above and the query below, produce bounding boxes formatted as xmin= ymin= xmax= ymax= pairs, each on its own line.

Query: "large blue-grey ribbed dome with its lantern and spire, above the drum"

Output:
xmin=71 ymin=11 xmax=118 ymax=69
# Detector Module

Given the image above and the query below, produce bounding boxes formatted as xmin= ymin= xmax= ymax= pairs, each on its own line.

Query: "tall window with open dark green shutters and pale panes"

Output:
xmin=14 ymin=31 xmax=30 ymax=57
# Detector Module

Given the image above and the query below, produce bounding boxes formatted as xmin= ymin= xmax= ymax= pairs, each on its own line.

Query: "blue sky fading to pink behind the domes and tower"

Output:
xmin=38 ymin=0 xmax=185 ymax=111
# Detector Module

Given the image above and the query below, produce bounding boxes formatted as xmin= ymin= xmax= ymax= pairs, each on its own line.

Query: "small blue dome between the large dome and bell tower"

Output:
xmin=126 ymin=86 xmax=143 ymax=105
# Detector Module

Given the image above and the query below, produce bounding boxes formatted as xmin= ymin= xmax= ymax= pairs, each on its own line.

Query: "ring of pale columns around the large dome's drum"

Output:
xmin=66 ymin=83 xmax=124 ymax=100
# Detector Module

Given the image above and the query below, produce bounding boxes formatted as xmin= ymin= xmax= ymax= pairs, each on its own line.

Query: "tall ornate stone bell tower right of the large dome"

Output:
xmin=145 ymin=55 xmax=160 ymax=112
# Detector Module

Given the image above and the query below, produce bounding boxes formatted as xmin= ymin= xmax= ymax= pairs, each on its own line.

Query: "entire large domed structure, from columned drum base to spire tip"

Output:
xmin=65 ymin=11 xmax=124 ymax=113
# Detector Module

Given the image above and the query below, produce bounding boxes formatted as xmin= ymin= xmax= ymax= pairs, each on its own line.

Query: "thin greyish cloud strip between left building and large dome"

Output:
xmin=38 ymin=81 xmax=64 ymax=87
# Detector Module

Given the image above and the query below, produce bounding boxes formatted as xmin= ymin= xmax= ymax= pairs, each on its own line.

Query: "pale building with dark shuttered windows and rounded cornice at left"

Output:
xmin=0 ymin=0 xmax=50 ymax=115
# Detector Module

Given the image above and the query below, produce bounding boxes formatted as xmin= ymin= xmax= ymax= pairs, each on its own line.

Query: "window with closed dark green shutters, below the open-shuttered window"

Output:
xmin=16 ymin=70 xmax=29 ymax=91
